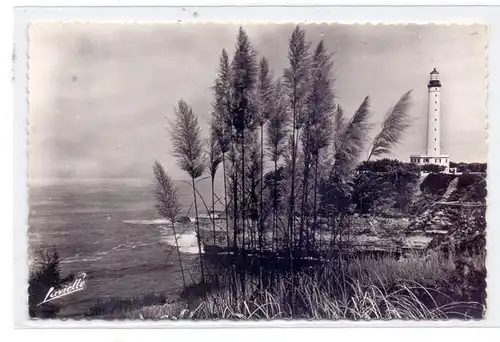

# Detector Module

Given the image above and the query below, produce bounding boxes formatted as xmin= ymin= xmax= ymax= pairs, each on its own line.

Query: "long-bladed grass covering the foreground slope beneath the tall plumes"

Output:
xmin=103 ymin=254 xmax=485 ymax=320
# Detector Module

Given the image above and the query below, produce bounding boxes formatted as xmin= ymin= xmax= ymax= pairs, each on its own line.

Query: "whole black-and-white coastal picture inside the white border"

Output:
xmin=26 ymin=21 xmax=489 ymax=321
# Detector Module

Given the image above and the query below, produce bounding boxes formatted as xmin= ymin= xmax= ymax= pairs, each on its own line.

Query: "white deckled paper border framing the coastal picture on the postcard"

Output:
xmin=14 ymin=6 xmax=500 ymax=328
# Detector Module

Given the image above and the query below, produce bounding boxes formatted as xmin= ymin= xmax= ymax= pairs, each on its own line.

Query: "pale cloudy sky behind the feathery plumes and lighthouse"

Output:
xmin=29 ymin=23 xmax=487 ymax=179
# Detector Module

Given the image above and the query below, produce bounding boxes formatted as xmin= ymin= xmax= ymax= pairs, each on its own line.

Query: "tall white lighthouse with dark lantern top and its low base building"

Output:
xmin=410 ymin=68 xmax=450 ymax=172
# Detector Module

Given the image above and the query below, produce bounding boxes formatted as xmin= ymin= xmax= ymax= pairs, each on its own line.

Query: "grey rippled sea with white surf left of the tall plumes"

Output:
xmin=28 ymin=179 xmax=211 ymax=317
